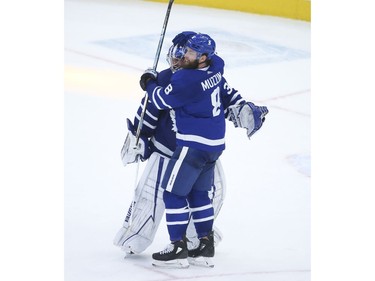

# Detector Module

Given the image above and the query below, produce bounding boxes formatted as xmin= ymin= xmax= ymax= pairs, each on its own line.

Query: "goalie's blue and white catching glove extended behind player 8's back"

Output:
xmin=228 ymin=102 xmax=268 ymax=139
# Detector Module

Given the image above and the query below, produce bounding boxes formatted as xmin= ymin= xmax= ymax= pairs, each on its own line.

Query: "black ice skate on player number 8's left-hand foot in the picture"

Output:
xmin=152 ymin=238 xmax=189 ymax=268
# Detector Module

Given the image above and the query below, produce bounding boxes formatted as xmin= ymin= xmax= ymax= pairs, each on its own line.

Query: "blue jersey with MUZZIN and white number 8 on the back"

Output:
xmin=147 ymin=56 xmax=225 ymax=151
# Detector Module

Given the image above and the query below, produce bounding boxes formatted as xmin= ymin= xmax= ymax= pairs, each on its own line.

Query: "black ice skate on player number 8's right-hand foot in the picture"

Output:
xmin=188 ymin=231 xmax=215 ymax=267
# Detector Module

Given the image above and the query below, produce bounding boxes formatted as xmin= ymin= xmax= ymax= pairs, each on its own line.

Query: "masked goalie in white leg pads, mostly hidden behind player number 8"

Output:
xmin=113 ymin=31 xmax=228 ymax=254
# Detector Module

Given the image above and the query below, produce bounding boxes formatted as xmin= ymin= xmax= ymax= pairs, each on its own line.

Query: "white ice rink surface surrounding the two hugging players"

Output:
xmin=64 ymin=0 xmax=311 ymax=281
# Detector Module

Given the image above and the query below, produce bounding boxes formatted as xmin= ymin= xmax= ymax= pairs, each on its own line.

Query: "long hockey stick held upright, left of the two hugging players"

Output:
xmin=123 ymin=0 xmax=174 ymax=228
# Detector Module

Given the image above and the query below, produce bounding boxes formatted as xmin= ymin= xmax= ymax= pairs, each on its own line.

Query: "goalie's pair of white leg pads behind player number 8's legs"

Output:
xmin=113 ymin=152 xmax=226 ymax=254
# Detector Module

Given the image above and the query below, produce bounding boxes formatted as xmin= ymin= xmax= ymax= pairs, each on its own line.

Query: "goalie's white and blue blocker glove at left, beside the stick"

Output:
xmin=121 ymin=119 xmax=151 ymax=166
